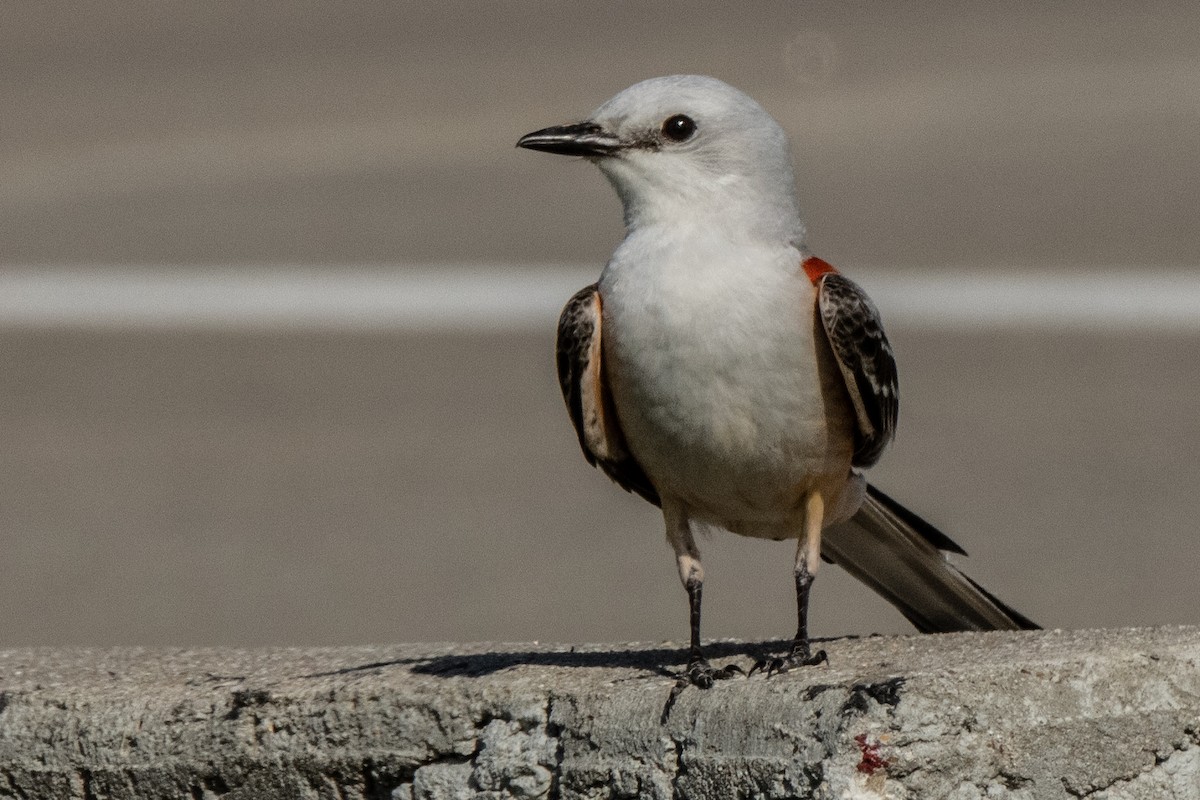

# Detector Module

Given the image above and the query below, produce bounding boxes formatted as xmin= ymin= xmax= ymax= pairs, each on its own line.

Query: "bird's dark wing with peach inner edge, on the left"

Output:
xmin=557 ymin=283 xmax=661 ymax=505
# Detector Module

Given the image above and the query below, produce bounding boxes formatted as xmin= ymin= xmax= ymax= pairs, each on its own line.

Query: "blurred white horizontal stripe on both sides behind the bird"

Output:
xmin=0 ymin=265 xmax=1200 ymax=332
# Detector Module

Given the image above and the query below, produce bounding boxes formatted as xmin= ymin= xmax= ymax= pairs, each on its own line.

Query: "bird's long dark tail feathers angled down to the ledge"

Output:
xmin=821 ymin=486 xmax=1038 ymax=633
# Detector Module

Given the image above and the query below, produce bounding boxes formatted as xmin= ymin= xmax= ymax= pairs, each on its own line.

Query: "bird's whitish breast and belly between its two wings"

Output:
xmin=600 ymin=227 xmax=853 ymax=536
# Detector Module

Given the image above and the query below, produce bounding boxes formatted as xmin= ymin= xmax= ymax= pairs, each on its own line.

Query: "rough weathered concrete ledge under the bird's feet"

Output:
xmin=0 ymin=627 xmax=1200 ymax=800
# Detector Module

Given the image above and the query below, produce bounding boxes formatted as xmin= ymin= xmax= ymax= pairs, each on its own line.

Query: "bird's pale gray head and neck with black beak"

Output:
xmin=517 ymin=76 xmax=804 ymax=246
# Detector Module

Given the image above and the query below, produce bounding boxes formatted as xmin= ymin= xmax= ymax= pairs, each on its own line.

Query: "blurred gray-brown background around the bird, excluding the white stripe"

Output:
xmin=0 ymin=0 xmax=1200 ymax=646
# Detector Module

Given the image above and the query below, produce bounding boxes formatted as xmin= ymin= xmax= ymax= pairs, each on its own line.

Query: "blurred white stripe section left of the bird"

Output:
xmin=0 ymin=266 xmax=595 ymax=331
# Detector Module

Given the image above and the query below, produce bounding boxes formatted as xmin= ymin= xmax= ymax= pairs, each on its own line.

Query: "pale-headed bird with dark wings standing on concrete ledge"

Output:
xmin=517 ymin=76 xmax=1037 ymax=690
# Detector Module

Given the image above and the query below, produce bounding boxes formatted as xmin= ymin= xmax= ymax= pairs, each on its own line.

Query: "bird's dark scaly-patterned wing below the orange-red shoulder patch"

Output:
xmin=817 ymin=272 xmax=900 ymax=467
